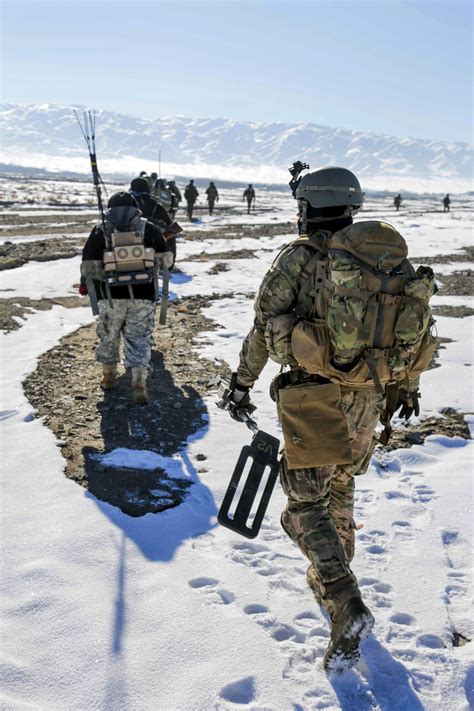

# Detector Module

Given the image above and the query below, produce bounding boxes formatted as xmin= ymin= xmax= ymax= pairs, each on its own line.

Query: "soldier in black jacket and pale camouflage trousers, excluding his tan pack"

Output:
xmin=80 ymin=193 xmax=173 ymax=403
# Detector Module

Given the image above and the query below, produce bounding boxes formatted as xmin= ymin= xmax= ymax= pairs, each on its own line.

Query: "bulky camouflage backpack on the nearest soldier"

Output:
xmin=266 ymin=221 xmax=436 ymax=391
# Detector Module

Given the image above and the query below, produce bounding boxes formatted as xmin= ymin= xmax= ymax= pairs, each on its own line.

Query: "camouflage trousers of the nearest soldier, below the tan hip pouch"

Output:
xmin=280 ymin=388 xmax=384 ymax=614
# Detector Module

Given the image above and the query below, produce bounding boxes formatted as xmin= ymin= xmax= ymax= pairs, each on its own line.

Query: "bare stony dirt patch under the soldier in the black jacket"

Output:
xmin=24 ymin=298 xmax=229 ymax=516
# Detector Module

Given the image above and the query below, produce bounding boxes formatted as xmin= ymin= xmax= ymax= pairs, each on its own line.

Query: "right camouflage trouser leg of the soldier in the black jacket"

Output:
xmin=123 ymin=299 xmax=156 ymax=369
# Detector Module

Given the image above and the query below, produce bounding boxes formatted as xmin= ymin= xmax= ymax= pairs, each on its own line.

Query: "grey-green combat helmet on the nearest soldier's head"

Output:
xmin=294 ymin=166 xmax=364 ymax=223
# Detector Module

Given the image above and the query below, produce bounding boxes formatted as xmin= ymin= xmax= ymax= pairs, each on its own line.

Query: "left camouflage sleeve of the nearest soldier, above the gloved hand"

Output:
xmin=237 ymin=245 xmax=314 ymax=387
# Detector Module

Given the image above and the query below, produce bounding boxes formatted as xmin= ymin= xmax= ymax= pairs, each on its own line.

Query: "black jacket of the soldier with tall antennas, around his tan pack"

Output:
xmin=81 ymin=213 xmax=170 ymax=301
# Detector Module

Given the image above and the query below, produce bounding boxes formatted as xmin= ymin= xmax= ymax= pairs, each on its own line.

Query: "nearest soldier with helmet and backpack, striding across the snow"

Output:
xmin=220 ymin=167 xmax=435 ymax=671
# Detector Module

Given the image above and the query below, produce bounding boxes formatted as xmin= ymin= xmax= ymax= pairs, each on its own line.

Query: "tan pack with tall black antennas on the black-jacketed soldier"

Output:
xmin=74 ymin=111 xmax=169 ymax=325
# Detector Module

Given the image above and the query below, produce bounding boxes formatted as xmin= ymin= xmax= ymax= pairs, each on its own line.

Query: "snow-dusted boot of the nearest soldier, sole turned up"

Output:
xmin=324 ymin=595 xmax=375 ymax=672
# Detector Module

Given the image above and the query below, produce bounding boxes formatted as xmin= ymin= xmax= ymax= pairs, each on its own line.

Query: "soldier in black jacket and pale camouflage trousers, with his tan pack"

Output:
xmin=80 ymin=192 xmax=173 ymax=403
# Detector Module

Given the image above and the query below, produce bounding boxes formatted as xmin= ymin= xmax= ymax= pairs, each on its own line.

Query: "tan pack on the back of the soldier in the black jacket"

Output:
xmin=104 ymin=218 xmax=155 ymax=286
